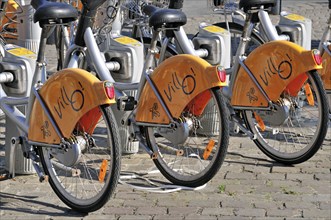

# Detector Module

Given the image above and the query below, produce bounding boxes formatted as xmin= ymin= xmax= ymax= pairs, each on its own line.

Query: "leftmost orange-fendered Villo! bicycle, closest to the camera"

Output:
xmin=0 ymin=0 xmax=121 ymax=213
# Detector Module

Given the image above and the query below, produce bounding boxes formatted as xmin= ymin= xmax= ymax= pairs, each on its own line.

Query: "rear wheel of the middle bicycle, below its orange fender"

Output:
xmin=145 ymin=88 xmax=229 ymax=187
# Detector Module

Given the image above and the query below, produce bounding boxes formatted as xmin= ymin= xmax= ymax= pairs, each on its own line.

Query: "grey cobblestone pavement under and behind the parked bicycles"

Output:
xmin=0 ymin=0 xmax=331 ymax=220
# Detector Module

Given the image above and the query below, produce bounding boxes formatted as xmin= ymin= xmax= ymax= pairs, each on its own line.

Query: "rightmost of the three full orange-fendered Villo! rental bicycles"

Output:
xmin=131 ymin=0 xmax=328 ymax=164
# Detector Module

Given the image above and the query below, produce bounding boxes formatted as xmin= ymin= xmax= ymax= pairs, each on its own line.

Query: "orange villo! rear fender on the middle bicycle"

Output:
xmin=136 ymin=54 xmax=226 ymax=124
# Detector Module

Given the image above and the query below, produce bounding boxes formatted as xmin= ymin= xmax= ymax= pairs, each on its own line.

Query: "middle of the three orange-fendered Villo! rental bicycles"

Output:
xmin=56 ymin=0 xmax=229 ymax=187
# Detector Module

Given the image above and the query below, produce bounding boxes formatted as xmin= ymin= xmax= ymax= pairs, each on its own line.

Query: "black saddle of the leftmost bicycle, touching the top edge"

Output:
xmin=31 ymin=0 xmax=78 ymax=27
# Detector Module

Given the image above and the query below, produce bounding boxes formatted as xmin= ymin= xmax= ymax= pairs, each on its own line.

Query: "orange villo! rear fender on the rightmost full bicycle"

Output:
xmin=231 ymin=41 xmax=322 ymax=107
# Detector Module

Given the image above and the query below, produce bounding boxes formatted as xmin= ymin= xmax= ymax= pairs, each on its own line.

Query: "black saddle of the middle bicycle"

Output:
xmin=143 ymin=5 xmax=187 ymax=29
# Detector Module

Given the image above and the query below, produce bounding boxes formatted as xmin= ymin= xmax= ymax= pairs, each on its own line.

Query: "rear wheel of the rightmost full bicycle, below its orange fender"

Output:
xmin=243 ymin=71 xmax=329 ymax=164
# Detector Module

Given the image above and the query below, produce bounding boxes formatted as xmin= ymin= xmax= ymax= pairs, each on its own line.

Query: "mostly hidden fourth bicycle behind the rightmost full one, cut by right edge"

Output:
xmin=210 ymin=1 xmax=331 ymax=113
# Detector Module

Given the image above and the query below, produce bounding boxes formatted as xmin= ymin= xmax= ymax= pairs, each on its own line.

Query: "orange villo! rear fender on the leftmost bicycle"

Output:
xmin=28 ymin=68 xmax=115 ymax=144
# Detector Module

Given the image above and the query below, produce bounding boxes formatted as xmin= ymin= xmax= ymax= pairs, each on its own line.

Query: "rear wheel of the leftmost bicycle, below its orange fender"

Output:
xmin=39 ymin=106 xmax=121 ymax=213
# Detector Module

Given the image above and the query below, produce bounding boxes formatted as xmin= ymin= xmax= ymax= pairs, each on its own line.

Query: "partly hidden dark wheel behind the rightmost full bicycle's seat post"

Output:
xmin=214 ymin=22 xmax=265 ymax=63
